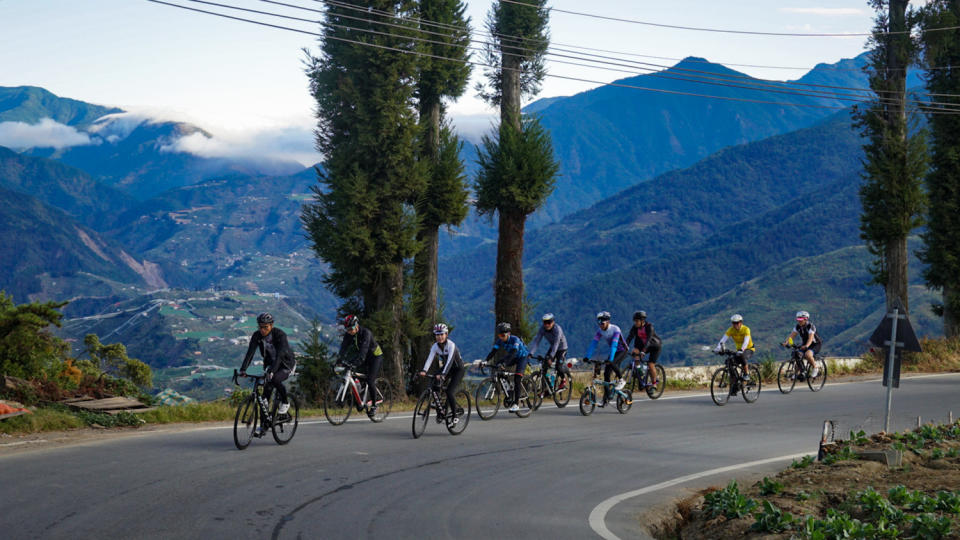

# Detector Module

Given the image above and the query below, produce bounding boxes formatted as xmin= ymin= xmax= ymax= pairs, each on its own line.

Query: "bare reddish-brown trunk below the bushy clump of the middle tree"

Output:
xmin=493 ymin=210 xmax=527 ymax=330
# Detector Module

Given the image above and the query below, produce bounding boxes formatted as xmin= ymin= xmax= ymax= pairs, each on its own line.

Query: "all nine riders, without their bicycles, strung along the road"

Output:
xmin=240 ymin=311 xmax=822 ymax=430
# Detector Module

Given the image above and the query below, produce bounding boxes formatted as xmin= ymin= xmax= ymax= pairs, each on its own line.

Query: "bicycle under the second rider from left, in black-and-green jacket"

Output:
xmin=323 ymin=362 xmax=393 ymax=426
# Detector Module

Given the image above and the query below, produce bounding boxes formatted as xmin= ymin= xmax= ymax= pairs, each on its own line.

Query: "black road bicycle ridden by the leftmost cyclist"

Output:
xmin=233 ymin=370 xmax=300 ymax=450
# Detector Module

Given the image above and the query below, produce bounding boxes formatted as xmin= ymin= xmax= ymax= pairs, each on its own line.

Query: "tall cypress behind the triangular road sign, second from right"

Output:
xmin=855 ymin=0 xmax=926 ymax=310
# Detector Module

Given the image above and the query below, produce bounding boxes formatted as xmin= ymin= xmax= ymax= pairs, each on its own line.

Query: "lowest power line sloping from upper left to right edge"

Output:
xmin=147 ymin=0 xmax=954 ymax=114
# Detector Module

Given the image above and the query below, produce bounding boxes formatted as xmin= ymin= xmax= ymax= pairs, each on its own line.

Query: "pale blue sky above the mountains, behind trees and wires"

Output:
xmin=0 ymin=0 xmax=916 ymax=161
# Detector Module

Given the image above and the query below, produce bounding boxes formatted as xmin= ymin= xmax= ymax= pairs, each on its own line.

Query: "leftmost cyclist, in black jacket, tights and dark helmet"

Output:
xmin=240 ymin=313 xmax=297 ymax=422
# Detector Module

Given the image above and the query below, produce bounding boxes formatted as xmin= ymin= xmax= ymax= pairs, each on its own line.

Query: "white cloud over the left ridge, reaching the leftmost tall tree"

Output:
xmin=161 ymin=126 xmax=321 ymax=166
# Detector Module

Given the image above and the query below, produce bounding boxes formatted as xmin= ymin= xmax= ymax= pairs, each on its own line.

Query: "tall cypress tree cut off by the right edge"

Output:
xmin=918 ymin=0 xmax=960 ymax=337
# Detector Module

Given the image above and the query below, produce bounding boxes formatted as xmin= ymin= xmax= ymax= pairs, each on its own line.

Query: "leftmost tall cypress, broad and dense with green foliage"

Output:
xmin=301 ymin=0 xmax=426 ymax=388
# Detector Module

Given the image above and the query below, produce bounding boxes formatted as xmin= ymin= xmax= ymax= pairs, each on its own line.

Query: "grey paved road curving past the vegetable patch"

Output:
xmin=0 ymin=374 xmax=960 ymax=539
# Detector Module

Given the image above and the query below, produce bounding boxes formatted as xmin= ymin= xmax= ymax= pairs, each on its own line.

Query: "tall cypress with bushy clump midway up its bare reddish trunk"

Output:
xmin=474 ymin=0 xmax=559 ymax=338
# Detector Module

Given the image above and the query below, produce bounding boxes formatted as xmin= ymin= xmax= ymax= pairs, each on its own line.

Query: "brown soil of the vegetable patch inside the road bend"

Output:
xmin=648 ymin=424 xmax=960 ymax=540
